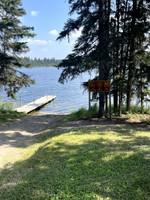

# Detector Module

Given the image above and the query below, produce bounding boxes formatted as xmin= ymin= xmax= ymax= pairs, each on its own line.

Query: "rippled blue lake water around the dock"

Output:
xmin=0 ymin=67 xmax=95 ymax=113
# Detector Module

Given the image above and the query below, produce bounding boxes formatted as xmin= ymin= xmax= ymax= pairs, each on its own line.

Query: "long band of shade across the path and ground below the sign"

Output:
xmin=0 ymin=114 xmax=146 ymax=148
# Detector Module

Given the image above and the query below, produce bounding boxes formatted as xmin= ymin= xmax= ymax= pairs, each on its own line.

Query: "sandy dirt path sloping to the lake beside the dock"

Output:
xmin=0 ymin=113 xmax=62 ymax=170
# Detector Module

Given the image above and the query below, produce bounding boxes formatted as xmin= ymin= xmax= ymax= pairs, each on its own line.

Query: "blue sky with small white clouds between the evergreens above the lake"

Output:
xmin=21 ymin=0 xmax=81 ymax=59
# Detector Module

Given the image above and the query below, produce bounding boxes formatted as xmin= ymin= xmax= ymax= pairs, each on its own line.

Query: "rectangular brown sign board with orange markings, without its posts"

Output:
xmin=88 ymin=80 xmax=110 ymax=92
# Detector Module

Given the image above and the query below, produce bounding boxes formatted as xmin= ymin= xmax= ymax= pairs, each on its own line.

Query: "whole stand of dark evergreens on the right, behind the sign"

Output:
xmin=58 ymin=0 xmax=150 ymax=116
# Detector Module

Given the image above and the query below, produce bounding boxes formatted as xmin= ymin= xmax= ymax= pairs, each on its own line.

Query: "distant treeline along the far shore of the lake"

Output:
xmin=24 ymin=57 xmax=61 ymax=67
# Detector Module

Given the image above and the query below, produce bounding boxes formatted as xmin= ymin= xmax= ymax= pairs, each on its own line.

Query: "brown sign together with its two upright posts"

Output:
xmin=88 ymin=80 xmax=111 ymax=119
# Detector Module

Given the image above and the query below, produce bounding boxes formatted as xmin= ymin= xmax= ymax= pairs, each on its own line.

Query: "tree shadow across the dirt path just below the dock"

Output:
xmin=0 ymin=114 xmax=64 ymax=148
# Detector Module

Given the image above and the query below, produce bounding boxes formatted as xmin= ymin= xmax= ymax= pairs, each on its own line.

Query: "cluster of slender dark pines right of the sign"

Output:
xmin=110 ymin=0 xmax=150 ymax=114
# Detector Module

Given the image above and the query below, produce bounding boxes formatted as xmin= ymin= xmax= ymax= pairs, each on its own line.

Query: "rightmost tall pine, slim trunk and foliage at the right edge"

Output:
xmin=127 ymin=0 xmax=150 ymax=111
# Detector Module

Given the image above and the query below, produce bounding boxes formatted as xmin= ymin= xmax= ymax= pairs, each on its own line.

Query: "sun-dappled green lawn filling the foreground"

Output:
xmin=0 ymin=119 xmax=150 ymax=200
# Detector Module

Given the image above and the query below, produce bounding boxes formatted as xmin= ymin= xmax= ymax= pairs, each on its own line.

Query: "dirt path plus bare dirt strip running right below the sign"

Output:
xmin=0 ymin=113 xmax=149 ymax=171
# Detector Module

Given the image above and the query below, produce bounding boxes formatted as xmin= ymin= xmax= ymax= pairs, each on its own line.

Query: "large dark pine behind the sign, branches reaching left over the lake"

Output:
xmin=58 ymin=0 xmax=110 ymax=117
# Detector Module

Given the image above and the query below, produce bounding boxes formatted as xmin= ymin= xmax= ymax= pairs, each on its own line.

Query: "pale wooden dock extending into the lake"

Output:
xmin=14 ymin=96 xmax=56 ymax=114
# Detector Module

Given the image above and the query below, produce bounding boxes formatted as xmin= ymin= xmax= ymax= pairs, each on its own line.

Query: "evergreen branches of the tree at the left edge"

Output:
xmin=0 ymin=0 xmax=35 ymax=98
